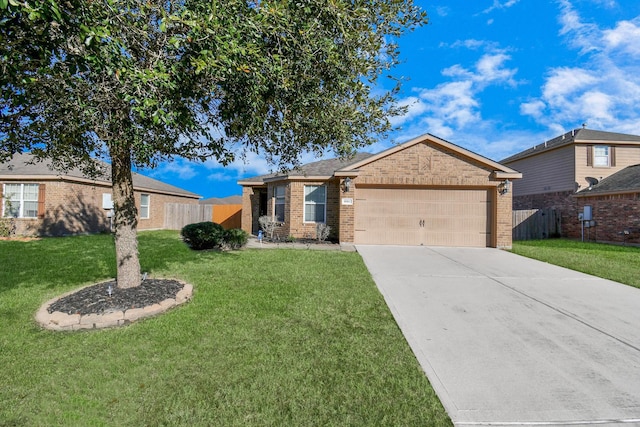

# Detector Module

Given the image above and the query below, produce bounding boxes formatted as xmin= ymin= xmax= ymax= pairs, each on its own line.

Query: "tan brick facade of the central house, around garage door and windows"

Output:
xmin=242 ymin=138 xmax=519 ymax=248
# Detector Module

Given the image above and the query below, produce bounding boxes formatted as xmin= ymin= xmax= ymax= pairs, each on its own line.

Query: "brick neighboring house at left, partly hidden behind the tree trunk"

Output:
xmin=0 ymin=154 xmax=200 ymax=236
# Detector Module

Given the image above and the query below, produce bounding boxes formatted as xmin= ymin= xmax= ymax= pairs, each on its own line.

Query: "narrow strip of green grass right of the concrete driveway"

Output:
xmin=512 ymin=239 xmax=640 ymax=288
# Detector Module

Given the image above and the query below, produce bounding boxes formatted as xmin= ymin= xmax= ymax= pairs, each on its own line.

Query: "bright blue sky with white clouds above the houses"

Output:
xmin=140 ymin=0 xmax=640 ymax=198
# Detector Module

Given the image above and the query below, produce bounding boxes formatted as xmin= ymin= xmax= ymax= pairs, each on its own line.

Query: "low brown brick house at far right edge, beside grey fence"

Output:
xmin=575 ymin=164 xmax=640 ymax=243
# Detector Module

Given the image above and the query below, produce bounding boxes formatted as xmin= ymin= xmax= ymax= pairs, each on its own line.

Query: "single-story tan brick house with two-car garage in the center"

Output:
xmin=239 ymin=134 xmax=521 ymax=247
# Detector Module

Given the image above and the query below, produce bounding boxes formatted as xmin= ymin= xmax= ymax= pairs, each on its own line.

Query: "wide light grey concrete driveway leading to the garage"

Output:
xmin=357 ymin=246 xmax=640 ymax=426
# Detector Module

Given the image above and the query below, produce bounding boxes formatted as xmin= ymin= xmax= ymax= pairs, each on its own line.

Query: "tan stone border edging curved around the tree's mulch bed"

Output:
xmin=35 ymin=279 xmax=193 ymax=331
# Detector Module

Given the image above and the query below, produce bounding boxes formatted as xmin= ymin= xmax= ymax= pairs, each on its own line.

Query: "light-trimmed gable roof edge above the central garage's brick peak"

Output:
xmin=336 ymin=133 xmax=522 ymax=179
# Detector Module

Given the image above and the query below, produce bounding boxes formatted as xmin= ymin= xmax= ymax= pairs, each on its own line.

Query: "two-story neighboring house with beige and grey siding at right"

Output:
xmin=501 ymin=129 xmax=640 ymax=238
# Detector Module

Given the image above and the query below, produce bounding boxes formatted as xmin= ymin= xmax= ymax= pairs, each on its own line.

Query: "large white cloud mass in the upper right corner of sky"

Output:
xmin=520 ymin=0 xmax=640 ymax=134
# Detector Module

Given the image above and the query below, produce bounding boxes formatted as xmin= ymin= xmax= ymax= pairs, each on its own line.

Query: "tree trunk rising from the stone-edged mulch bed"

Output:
xmin=110 ymin=144 xmax=141 ymax=289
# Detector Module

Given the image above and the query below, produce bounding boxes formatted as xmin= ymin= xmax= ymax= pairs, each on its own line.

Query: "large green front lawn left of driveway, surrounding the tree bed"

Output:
xmin=0 ymin=232 xmax=450 ymax=426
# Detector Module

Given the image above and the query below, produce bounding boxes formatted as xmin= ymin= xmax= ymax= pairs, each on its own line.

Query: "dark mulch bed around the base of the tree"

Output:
xmin=48 ymin=279 xmax=184 ymax=315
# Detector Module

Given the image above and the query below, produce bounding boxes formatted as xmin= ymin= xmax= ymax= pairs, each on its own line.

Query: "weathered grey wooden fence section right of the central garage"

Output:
xmin=513 ymin=208 xmax=561 ymax=240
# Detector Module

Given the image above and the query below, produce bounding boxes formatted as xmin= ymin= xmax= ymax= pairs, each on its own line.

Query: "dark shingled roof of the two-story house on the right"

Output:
xmin=500 ymin=128 xmax=640 ymax=163
